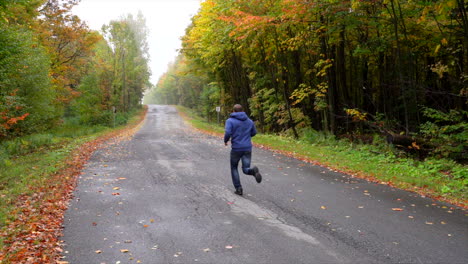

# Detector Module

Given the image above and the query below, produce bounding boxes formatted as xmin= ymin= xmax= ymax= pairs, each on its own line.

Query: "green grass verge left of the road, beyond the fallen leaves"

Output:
xmin=0 ymin=106 xmax=145 ymax=248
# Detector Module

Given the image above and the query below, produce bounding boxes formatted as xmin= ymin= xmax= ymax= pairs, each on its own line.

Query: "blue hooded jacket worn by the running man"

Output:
xmin=224 ymin=112 xmax=257 ymax=151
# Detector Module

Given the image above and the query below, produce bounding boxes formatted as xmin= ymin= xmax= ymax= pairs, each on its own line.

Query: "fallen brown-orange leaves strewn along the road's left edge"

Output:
xmin=0 ymin=106 xmax=147 ymax=264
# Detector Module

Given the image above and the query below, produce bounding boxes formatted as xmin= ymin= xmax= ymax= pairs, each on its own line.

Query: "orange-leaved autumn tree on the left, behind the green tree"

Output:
xmin=36 ymin=0 xmax=99 ymax=104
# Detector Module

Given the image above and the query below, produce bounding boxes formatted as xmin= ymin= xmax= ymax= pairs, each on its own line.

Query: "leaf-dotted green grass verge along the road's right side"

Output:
xmin=178 ymin=107 xmax=468 ymax=208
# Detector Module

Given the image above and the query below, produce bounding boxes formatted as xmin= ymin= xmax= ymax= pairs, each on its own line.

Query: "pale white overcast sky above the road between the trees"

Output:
xmin=73 ymin=0 xmax=202 ymax=84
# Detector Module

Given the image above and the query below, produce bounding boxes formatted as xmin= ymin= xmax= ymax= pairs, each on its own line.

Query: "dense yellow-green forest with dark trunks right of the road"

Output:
xmin=146 ymin=0 xmax=468 ymax=163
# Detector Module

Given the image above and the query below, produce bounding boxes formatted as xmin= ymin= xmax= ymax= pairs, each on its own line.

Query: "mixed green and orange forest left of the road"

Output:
xmin=0 ymin=0 xmax=150 ymax=140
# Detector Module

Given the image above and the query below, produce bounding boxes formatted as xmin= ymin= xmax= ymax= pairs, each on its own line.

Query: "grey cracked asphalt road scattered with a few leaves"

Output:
xmin=62 ymin=106 xmax=468 ymax=264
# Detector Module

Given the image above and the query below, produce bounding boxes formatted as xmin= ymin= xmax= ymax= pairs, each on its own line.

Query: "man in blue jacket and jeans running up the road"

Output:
xmin=224 ymin=104 xmax=262 ymax=195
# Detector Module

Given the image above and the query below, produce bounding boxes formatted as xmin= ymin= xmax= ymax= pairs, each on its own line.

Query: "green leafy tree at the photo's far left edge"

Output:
xmin=0 ymin=26 xmax=61 ymax=137
